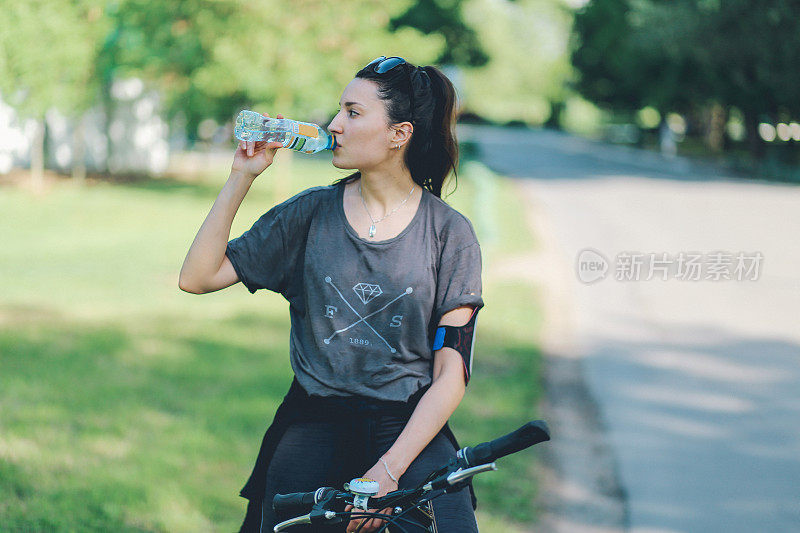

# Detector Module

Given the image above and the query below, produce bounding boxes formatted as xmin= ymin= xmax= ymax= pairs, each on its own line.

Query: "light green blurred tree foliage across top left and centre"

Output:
xmin=0 ymin=0 xmax=570 ymax=143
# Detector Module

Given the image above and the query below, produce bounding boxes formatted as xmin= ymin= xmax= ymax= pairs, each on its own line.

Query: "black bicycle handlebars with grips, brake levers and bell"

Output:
xmin=272 ymin=420 xmax=550 ymax=533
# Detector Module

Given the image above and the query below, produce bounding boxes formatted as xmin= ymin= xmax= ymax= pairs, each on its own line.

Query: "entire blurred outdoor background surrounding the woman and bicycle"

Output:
xmin=0 ymin=0 xmax=800 ymax=533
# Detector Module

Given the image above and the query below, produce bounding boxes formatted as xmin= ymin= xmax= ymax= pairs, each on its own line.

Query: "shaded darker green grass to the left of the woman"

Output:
xmin=0 ymin=309 xmax=291 ymax=531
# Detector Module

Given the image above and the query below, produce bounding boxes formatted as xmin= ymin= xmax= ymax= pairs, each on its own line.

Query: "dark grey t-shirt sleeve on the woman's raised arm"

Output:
xmin=225 ymin=189 xmax=314 ymax=294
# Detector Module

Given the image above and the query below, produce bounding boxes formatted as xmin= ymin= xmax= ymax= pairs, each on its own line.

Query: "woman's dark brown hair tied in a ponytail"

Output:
xmin=334 ymin=60 xmax=458 ymax=198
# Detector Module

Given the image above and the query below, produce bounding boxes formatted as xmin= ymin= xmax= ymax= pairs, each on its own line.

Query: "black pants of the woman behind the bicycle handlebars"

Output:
xmin=261 ymin=416 xmax=478 ymax=533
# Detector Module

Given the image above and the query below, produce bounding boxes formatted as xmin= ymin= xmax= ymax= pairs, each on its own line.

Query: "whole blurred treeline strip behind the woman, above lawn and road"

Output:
xmin=0 ymin=0 xmax=800 ymax=185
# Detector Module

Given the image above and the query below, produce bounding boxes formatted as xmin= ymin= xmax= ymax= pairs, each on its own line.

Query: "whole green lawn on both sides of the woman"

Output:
xmin=0 ymin=152 xmax=541 ymax=532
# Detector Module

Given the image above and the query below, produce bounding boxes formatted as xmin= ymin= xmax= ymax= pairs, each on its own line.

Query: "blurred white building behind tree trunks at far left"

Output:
xmin=0 ymin=78 xmax=169 ymax=174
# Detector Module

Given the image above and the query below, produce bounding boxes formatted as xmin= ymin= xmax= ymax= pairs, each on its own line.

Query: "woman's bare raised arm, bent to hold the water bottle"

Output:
xmin=178 ymin=115 xmax=283 ymax=294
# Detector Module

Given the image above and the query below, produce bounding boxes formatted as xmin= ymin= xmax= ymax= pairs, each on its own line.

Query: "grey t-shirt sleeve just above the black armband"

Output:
xmin=432 ymin=215 xmax=483 ymax=327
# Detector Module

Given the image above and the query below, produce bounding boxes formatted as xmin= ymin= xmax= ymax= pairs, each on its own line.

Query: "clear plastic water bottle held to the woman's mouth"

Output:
xmin=233 ymin=110 xmax=336 ymax=154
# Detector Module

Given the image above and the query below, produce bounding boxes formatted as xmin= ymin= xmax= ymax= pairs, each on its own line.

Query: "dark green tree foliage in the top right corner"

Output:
xmin=571 ymin=0 xmax=800 ymax=154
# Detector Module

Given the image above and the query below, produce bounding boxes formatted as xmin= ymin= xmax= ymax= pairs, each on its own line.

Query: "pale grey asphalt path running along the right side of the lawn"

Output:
xmin=459 ymin=123 xmax=800 ymax=533
